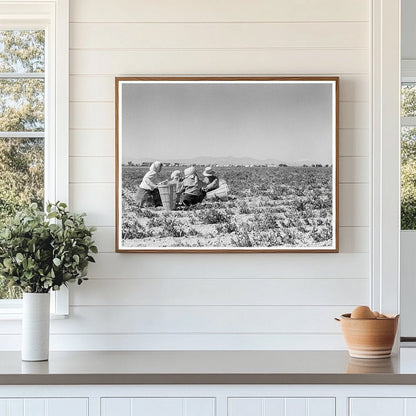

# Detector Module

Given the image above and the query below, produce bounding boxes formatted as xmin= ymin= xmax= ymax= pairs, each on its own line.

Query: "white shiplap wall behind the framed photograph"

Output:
xmin=43 ymin=0 xmax=371 ymax=349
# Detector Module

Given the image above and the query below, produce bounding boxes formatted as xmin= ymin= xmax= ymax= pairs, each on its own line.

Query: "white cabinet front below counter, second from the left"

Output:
xmin=101 ymin=397 xmax=215 ymax=416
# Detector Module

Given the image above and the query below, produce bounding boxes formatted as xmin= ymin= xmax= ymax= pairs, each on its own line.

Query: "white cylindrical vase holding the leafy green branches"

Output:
xmin=22 ymin=293 xmax=50 ymax=361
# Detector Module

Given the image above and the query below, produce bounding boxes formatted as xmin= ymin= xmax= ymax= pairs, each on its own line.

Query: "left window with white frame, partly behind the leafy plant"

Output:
xmin=0 ymin=0 xmax=69 ymax=314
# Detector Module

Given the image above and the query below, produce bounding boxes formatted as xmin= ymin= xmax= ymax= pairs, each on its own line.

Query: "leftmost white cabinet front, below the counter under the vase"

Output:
xmin=0 ymin=398 xmax=88 ymax=416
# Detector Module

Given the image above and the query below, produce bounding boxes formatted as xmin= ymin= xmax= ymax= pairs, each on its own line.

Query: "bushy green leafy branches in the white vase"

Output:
xmin=0 ymin=202 xmax=97 ymax=293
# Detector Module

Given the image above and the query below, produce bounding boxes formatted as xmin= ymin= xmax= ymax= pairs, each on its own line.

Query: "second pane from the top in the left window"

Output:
xmin=0 ymin=78 xmax=45 ymax=132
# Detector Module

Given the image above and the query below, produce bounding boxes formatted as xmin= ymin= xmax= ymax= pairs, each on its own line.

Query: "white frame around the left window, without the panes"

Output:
xmin=0 ymin=0 xmax=69 ymax=319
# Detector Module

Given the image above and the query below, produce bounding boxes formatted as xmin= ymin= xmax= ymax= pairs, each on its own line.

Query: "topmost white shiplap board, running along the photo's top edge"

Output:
xmin=70 ymin=0 xmax=369 ymax=23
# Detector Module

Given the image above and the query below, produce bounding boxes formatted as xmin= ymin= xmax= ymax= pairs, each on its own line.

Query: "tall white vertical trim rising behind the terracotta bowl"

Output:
xmin=369 ymin=0 xmax=401 ymax=322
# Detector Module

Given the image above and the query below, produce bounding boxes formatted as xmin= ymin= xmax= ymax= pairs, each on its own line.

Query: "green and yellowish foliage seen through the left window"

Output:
xmin=0 ymin=30 xmax=45 ymax=299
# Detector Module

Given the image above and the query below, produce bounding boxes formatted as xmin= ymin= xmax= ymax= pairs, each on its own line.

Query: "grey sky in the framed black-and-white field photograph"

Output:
xmin=121 ymin=82 xmax=332 ymax=164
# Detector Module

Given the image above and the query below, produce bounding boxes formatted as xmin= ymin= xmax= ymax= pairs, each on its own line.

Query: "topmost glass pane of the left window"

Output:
xmin=0 ymin=30 xmax=45 ymax=73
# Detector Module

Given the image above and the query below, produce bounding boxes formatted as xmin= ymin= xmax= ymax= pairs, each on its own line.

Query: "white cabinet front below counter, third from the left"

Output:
xmin=228 ymin=397 xmax=335 ymax=416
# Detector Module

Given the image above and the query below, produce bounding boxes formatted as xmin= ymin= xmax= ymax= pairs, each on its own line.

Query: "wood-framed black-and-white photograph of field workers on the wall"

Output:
xmin=115 ymin=77 xmax=338 ymax=252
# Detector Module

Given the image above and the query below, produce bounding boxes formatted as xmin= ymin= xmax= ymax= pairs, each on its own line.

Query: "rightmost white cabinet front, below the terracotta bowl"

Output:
xmin=349 ymin=397 xmax=416 ymax=416
